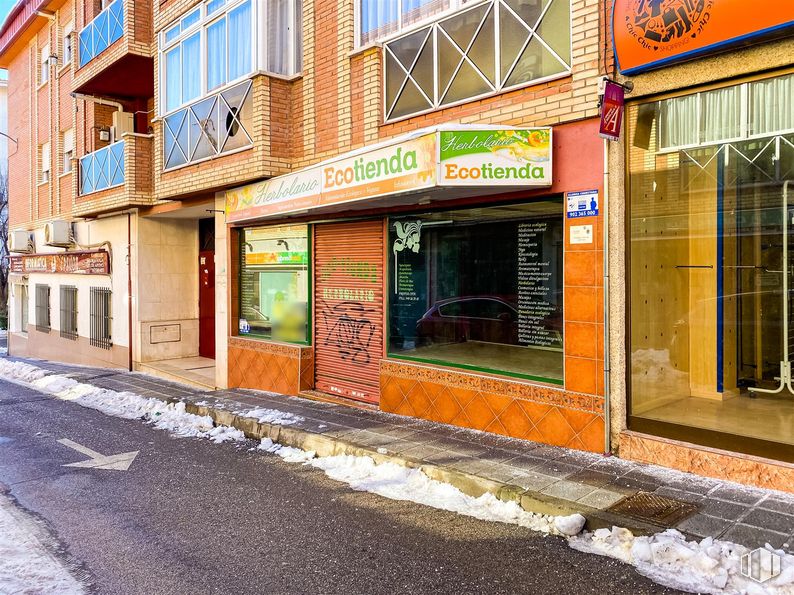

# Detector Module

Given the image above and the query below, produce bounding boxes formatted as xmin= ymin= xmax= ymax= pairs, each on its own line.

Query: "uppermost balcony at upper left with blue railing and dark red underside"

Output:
xmin=73 ymin=0 xmax=154 ymax=98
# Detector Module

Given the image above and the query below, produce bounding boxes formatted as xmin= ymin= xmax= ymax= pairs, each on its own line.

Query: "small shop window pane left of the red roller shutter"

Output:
xmin=239 ymin=225 xmax=310 ymax=343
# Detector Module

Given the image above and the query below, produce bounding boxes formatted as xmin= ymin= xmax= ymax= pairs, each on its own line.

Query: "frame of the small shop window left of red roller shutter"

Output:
xmin=231 ymin=222 xmax=314 ymax=347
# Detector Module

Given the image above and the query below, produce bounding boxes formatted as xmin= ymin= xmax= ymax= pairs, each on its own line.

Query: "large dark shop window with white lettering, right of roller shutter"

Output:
xmin=388 ymin=200 xmax=563 ymax=384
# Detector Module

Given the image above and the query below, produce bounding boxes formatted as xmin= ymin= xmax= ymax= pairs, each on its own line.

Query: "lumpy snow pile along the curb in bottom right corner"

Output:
xmin=569 ymin=527 xmax=794 ymax=595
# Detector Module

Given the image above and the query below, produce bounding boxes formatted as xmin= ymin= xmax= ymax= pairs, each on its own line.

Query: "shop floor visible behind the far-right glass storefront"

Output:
xmin=641 ymin=391 xmax=794 ymax=444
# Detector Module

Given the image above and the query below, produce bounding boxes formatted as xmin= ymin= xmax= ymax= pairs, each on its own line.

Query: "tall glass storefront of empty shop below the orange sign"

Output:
xmin=627 ymin=75 xmax=794 ymax=460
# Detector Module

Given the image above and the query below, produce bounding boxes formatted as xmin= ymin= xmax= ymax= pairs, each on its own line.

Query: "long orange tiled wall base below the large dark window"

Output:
xmin=380 ymin=360 xmax=604 ymax=452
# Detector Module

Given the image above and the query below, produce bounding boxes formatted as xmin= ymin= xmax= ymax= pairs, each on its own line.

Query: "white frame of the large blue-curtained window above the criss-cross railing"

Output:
xmin=158 ymin=0 xmax=260 ymax=116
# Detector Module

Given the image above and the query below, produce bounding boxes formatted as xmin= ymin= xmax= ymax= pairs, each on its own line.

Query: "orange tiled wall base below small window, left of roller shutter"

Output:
xmin=229 ymin=337 xmax=314 ymax=395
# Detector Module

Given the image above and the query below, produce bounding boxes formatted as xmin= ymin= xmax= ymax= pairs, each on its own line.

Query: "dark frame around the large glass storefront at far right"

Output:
xmin=621 ymin=67 xmax=794 ymax=463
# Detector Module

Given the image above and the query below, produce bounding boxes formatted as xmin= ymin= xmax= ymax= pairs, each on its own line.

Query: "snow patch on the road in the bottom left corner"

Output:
xmin=0 ymin=496 xmax=85 ymax=595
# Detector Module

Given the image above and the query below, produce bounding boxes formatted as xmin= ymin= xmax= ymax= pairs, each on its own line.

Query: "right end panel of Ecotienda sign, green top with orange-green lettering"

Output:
xmin=439 ymin=128 xmax=551 ymax=186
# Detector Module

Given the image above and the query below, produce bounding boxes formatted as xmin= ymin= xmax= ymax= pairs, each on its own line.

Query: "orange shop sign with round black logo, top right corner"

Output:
xmin=612 ymin=0 xmax=794 ymax=74
